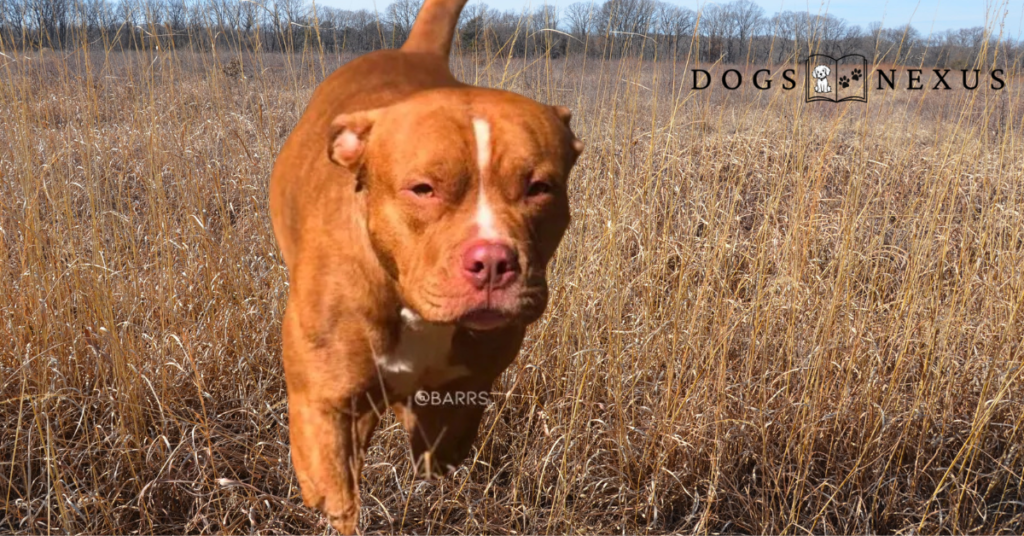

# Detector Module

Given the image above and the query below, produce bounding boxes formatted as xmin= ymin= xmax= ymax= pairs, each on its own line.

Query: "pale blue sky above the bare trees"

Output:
xmin=327 ymin=0 xmax=1024 ymax=38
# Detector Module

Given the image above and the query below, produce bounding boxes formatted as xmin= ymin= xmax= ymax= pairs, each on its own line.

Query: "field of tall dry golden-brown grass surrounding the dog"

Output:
xmin=0 ymin=43 xmax=1024 ymax=535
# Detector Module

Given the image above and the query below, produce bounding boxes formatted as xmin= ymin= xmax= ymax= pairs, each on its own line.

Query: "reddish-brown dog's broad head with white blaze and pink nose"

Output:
xmin=329 ymin=88 xmax=583 ymax=329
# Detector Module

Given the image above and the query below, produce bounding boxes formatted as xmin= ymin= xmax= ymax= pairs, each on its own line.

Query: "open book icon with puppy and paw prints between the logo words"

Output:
xmin=804 ymin=54 xmax=867 ymax=102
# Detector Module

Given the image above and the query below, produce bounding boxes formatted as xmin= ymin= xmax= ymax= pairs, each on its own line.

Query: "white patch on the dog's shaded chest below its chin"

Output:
xmin=375 ymin=308 xmax=469 ymax=396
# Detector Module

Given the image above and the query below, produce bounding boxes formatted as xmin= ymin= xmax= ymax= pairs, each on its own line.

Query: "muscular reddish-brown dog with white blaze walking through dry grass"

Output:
xmin=270 ymin=0 xmax=583 ymax=534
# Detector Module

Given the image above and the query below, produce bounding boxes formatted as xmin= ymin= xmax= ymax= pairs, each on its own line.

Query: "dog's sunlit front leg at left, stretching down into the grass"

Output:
xmin=283 ymin=307 xmax=381 ymax=535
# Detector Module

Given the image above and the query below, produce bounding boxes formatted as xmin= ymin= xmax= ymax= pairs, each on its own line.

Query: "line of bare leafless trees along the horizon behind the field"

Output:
xmin=0 ymin=0 xmax=1022 ymax=69
